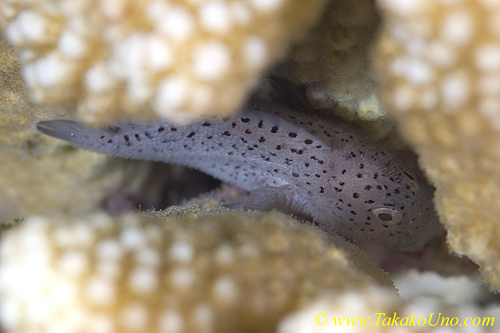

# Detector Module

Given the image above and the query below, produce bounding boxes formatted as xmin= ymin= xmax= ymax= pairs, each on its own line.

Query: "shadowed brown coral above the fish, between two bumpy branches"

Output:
xmin=278 ymin=0 xmax=385 ymax=120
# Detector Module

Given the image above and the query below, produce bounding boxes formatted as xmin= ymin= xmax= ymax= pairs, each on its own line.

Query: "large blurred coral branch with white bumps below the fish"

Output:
xmin=0 ymin=206 xmax=396 ymax=333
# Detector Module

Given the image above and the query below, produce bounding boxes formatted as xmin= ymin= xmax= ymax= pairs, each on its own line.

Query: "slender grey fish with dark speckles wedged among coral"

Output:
xmin=37 ymin=103 xmax=438 ymax=251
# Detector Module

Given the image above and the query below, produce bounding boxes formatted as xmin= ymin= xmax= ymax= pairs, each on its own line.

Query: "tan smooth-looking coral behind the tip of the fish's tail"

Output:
xmin=0 ymin=35 xmax=147 ymax=223
